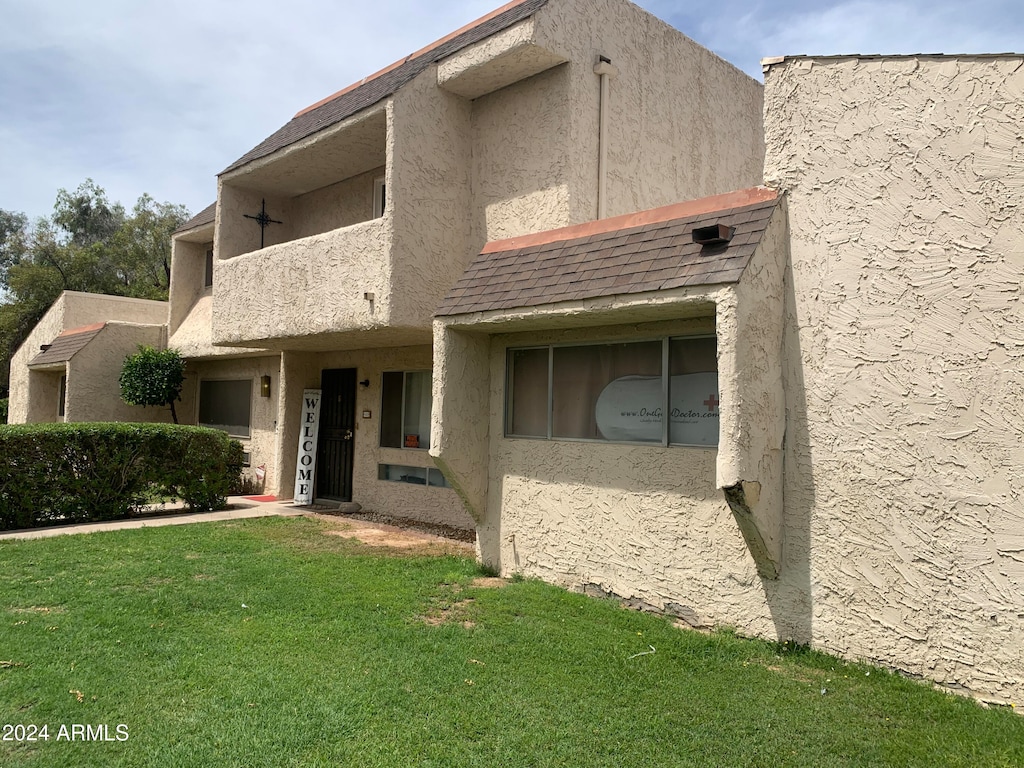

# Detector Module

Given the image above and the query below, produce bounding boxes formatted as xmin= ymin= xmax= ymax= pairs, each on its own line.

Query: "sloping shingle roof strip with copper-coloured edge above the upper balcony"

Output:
xmin=221 ymin=0 xmax=548 ymax=174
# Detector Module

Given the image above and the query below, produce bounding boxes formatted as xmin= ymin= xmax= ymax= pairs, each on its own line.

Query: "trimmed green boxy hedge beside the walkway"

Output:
xmin=0 ymin=423 xmax=242 ymax=530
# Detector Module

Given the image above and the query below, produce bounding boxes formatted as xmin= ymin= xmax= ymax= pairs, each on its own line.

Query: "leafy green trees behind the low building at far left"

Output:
xmin=0 ymin=179 xmax=188 ymax=394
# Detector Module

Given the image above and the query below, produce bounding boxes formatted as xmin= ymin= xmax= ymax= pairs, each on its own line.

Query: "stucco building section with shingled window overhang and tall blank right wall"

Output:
xmin=431 ymin=55 xmax=1024 ymax=702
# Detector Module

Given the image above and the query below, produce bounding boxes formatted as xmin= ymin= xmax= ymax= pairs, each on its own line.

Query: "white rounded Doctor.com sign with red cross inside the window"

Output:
xmin=594 ymin=373 xmax=719 ymax=445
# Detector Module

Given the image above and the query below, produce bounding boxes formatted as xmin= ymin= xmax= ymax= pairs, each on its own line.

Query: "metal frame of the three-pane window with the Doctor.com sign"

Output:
xmin=502 ymin=333 xmax=721 ymax=451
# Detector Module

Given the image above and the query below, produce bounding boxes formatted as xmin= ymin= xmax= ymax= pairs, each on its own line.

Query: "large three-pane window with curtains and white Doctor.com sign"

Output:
xmin=505 ymin=337 xmax=719 ymax=445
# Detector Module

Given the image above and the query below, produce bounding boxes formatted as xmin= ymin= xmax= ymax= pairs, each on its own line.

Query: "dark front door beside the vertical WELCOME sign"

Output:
xmin=315 ymin=368 xmax=355 ymax=502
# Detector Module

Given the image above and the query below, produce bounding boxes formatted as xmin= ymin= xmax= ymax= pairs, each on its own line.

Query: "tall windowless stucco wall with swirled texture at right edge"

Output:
xmin=765 ymin=56 xmax=1024 ymax=701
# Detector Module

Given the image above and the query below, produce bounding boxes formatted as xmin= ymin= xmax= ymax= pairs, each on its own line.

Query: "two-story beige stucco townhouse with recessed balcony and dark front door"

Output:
xmin=159 ymin=0 xmax=763 ymax=527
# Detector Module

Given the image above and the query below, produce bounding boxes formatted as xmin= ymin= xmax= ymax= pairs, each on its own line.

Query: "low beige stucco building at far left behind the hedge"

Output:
xmin=8 ymin=291 xmax=171 ymax=424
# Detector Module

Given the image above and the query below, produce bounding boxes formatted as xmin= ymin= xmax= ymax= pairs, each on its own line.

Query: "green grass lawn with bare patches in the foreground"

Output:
xmin=0 ymin=518 xmax=1024 ymax=768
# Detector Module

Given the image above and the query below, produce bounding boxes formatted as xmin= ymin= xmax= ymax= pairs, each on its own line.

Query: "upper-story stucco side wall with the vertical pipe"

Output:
xmin=536 ymin=0 xmax=764 ymax=223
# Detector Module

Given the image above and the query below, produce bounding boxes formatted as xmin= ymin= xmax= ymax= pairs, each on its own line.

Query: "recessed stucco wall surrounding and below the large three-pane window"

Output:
xmin=478 ymin=319 xmax=772 ymax=634
